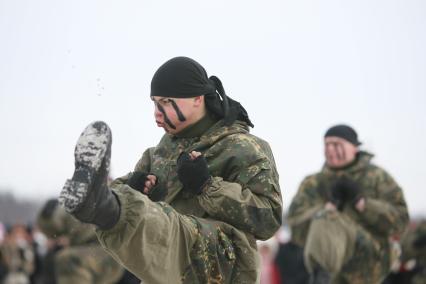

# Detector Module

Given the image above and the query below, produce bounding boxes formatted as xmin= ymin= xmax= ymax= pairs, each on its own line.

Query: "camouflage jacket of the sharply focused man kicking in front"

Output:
xmin=113 ymin=118 xmax=282 ymax=241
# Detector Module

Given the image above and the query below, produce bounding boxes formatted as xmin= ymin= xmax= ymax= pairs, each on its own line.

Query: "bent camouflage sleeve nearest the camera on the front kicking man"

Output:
xmin=199 ymin=142 xmax=282 ymax=239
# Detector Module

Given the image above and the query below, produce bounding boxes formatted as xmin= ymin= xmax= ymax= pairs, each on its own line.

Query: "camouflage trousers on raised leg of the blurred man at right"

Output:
xmin=304 ymin=211 xmax=390 ymax=284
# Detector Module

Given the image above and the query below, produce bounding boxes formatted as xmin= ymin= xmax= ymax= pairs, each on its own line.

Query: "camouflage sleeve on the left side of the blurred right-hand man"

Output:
xmin=287 ymin=176 xmax=325 ymax=246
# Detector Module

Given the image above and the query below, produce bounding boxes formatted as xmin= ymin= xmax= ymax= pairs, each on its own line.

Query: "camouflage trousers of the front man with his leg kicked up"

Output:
xmin=97 ymin=185 xmax=259 ymax=284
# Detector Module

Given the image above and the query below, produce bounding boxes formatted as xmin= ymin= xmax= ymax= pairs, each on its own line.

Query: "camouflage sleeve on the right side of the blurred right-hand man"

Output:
xmin=360 ymin=168 xmax=409 ymax=236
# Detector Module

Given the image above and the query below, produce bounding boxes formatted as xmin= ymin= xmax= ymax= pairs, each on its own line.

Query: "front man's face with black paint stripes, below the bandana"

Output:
xmin=151 ymin=97 xmax=201 ymax=134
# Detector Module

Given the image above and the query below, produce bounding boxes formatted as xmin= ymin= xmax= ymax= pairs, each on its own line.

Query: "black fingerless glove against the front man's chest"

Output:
xmin=177 ymin=152 xmax=211 ymax=195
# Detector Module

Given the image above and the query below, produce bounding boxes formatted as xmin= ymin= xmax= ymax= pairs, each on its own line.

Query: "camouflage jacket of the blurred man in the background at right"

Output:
xmin=288 ymin=152 xmax=409 ymax=250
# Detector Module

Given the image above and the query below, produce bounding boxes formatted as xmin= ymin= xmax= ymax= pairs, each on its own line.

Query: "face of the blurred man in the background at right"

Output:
xmin=324 ymin=136 xmax=358 ymax=168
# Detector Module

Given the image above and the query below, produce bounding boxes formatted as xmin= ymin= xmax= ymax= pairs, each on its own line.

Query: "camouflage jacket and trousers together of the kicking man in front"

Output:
xmin=98 ymin=118 xmax=282 ymax=283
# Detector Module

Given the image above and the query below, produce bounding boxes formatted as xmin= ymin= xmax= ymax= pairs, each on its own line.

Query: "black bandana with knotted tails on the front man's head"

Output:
xmin=151 ymin=57 xmax=253 ymax=127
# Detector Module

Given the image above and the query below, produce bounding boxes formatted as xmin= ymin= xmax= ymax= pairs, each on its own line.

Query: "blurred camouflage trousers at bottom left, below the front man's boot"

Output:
xmin=55 ymin=244 xmax=124 ymax=284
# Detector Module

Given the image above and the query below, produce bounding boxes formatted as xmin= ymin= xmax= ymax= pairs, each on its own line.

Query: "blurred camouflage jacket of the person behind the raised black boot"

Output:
xmin=37 ymin=203 xmax=97 ymax=246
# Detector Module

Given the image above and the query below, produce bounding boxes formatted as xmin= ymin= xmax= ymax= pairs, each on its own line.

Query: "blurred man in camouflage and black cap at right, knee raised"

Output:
xmin=288 ymin=125 xmax=408 ymax=284
